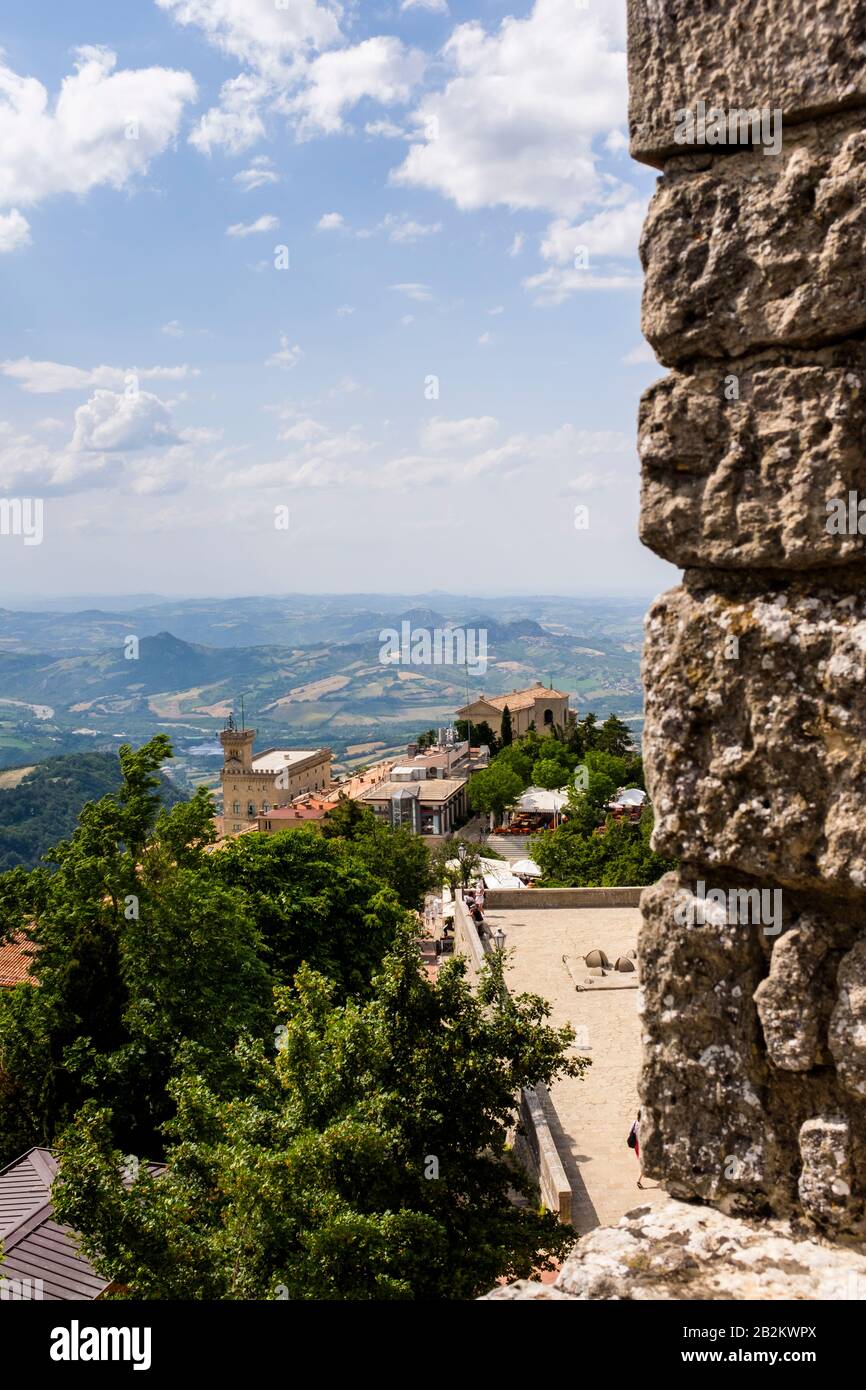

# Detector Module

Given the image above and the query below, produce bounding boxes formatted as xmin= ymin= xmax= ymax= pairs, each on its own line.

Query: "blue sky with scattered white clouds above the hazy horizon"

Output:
xmin=0 ymin=0 xmax=674 ymax=602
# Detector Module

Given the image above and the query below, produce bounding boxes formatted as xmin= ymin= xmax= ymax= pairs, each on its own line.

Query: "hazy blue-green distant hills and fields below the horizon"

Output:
xmin=0 ymin=595 xmax=645 ymax=783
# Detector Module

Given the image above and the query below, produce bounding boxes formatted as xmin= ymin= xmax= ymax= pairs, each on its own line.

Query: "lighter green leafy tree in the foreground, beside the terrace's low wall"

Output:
xmin=54 ymin=941 xmax=587 ymax=1301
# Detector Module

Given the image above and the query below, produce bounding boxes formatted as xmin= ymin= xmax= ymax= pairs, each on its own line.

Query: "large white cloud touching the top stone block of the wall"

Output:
xmin=392 ymin=0 xmax=627 ymax=215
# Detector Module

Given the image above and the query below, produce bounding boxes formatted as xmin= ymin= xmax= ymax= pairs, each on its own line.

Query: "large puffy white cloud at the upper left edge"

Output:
xmin=0 ymin=47 xmax=196 ymax=219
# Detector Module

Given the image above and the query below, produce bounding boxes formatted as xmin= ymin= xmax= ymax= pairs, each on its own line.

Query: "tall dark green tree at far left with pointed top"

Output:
xmin=0 ymin=735 xmax=272 ymax=1163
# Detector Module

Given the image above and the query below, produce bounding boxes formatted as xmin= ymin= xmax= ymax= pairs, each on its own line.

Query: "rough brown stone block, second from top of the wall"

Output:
xmin=641 ymin=111 xmax=866 ymax=367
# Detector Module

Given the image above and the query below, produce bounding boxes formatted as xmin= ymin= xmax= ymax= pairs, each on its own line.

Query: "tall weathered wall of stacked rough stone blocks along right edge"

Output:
xmin=628 ymin=0 xmax=866 ymax=1243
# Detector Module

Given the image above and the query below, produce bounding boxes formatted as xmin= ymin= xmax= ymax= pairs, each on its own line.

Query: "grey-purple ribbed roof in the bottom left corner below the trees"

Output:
xmin=0 ymin=1148 xmax=164 ymax=1302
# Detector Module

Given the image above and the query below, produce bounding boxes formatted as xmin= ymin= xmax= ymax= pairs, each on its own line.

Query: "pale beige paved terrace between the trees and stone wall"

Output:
xmin=485 ymin=891 xmax=666 ymax=1234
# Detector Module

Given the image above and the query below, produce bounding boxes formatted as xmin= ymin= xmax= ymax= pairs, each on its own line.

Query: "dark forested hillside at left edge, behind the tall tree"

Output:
xmin=0 ymin=753 xmax=185 ymax=872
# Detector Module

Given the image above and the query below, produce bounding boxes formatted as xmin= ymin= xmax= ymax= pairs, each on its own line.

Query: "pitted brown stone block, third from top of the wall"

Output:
xmin=638 ymin=358 xmax=866 ymax=570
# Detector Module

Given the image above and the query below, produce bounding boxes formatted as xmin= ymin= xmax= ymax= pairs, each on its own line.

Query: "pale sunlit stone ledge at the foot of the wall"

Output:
xmin=485 ymin=1201 xmax=866 ymax=1302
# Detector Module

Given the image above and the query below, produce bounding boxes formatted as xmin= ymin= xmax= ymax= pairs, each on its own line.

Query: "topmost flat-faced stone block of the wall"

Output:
xmin=628 ymin=0 xmax=866 ymax=165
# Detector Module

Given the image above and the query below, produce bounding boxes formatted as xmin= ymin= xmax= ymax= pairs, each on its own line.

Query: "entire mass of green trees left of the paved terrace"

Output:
xmin=0 ymin=735 xmax=587 ymax=1300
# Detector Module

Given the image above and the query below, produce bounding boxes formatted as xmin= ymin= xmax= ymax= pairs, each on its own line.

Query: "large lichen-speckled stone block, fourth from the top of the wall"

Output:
xmin=644 ymin=575 xmax=866 ymax=897
